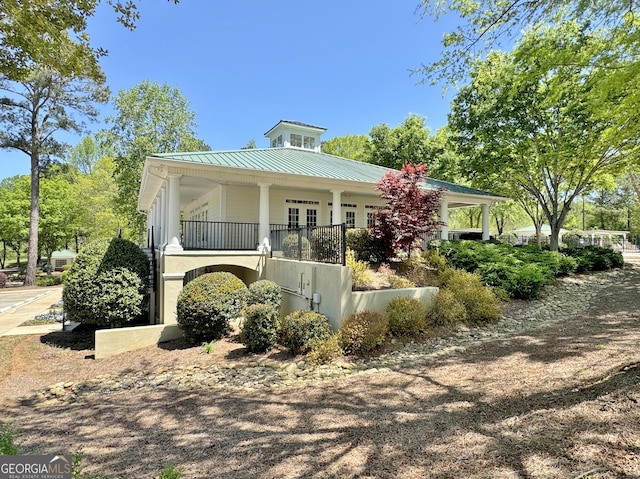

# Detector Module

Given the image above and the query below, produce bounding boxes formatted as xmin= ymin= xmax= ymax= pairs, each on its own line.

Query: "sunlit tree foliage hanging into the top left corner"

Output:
xmin=0 ymin=0 xmax=178 ymax=81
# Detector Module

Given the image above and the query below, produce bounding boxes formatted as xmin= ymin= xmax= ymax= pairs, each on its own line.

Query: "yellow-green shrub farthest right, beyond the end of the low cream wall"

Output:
xmin=441 ymin=268 xmax=502 ymax=324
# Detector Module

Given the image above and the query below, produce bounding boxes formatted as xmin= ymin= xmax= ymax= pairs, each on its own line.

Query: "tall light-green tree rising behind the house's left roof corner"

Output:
xmin=106 ymin=81 xmax=210 ymax=231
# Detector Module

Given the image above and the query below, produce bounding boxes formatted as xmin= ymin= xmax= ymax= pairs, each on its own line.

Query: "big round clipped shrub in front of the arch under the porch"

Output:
xmin=177 ymin=271 xmax=249 ymax=344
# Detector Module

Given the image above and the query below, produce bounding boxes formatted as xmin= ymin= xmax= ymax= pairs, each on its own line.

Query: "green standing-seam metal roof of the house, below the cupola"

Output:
xmin=152 ymin=147 xmax=500 ymax=197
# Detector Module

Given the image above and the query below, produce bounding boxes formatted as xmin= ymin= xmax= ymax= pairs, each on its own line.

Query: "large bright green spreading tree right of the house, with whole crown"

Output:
xmin=449 ymin=24 xmax=637 ymax=250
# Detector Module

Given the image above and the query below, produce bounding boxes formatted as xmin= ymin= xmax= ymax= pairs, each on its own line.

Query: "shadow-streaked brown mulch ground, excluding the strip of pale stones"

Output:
xmin=0 ymin=266 xmax=640 ymax=479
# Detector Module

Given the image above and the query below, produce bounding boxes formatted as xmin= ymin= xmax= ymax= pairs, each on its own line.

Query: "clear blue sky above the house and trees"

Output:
xmin=0 ymin=0 xmax=460 ymax=179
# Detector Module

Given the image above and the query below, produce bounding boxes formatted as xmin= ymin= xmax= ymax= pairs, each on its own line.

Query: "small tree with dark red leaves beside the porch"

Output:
xmin=373 ymin=163 xmax=442 ymax=255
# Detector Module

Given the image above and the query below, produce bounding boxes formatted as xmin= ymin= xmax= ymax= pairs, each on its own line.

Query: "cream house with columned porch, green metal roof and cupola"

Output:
xmin=138 ymin=120 xmax=505 ymax=330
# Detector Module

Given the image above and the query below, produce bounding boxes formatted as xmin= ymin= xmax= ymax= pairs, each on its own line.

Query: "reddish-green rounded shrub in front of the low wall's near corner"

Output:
xmin=339 ymin=311 xmax=389 ymax=355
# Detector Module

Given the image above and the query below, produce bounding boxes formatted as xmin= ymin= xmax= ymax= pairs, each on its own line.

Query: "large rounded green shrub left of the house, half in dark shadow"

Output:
xmin=62 ymin=238 xmax=149 ymax=326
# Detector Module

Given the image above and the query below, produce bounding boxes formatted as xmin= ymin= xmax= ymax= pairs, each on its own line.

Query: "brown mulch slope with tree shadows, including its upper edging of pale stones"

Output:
xmin=4 ymin=263 xmax=640 ymax=478
